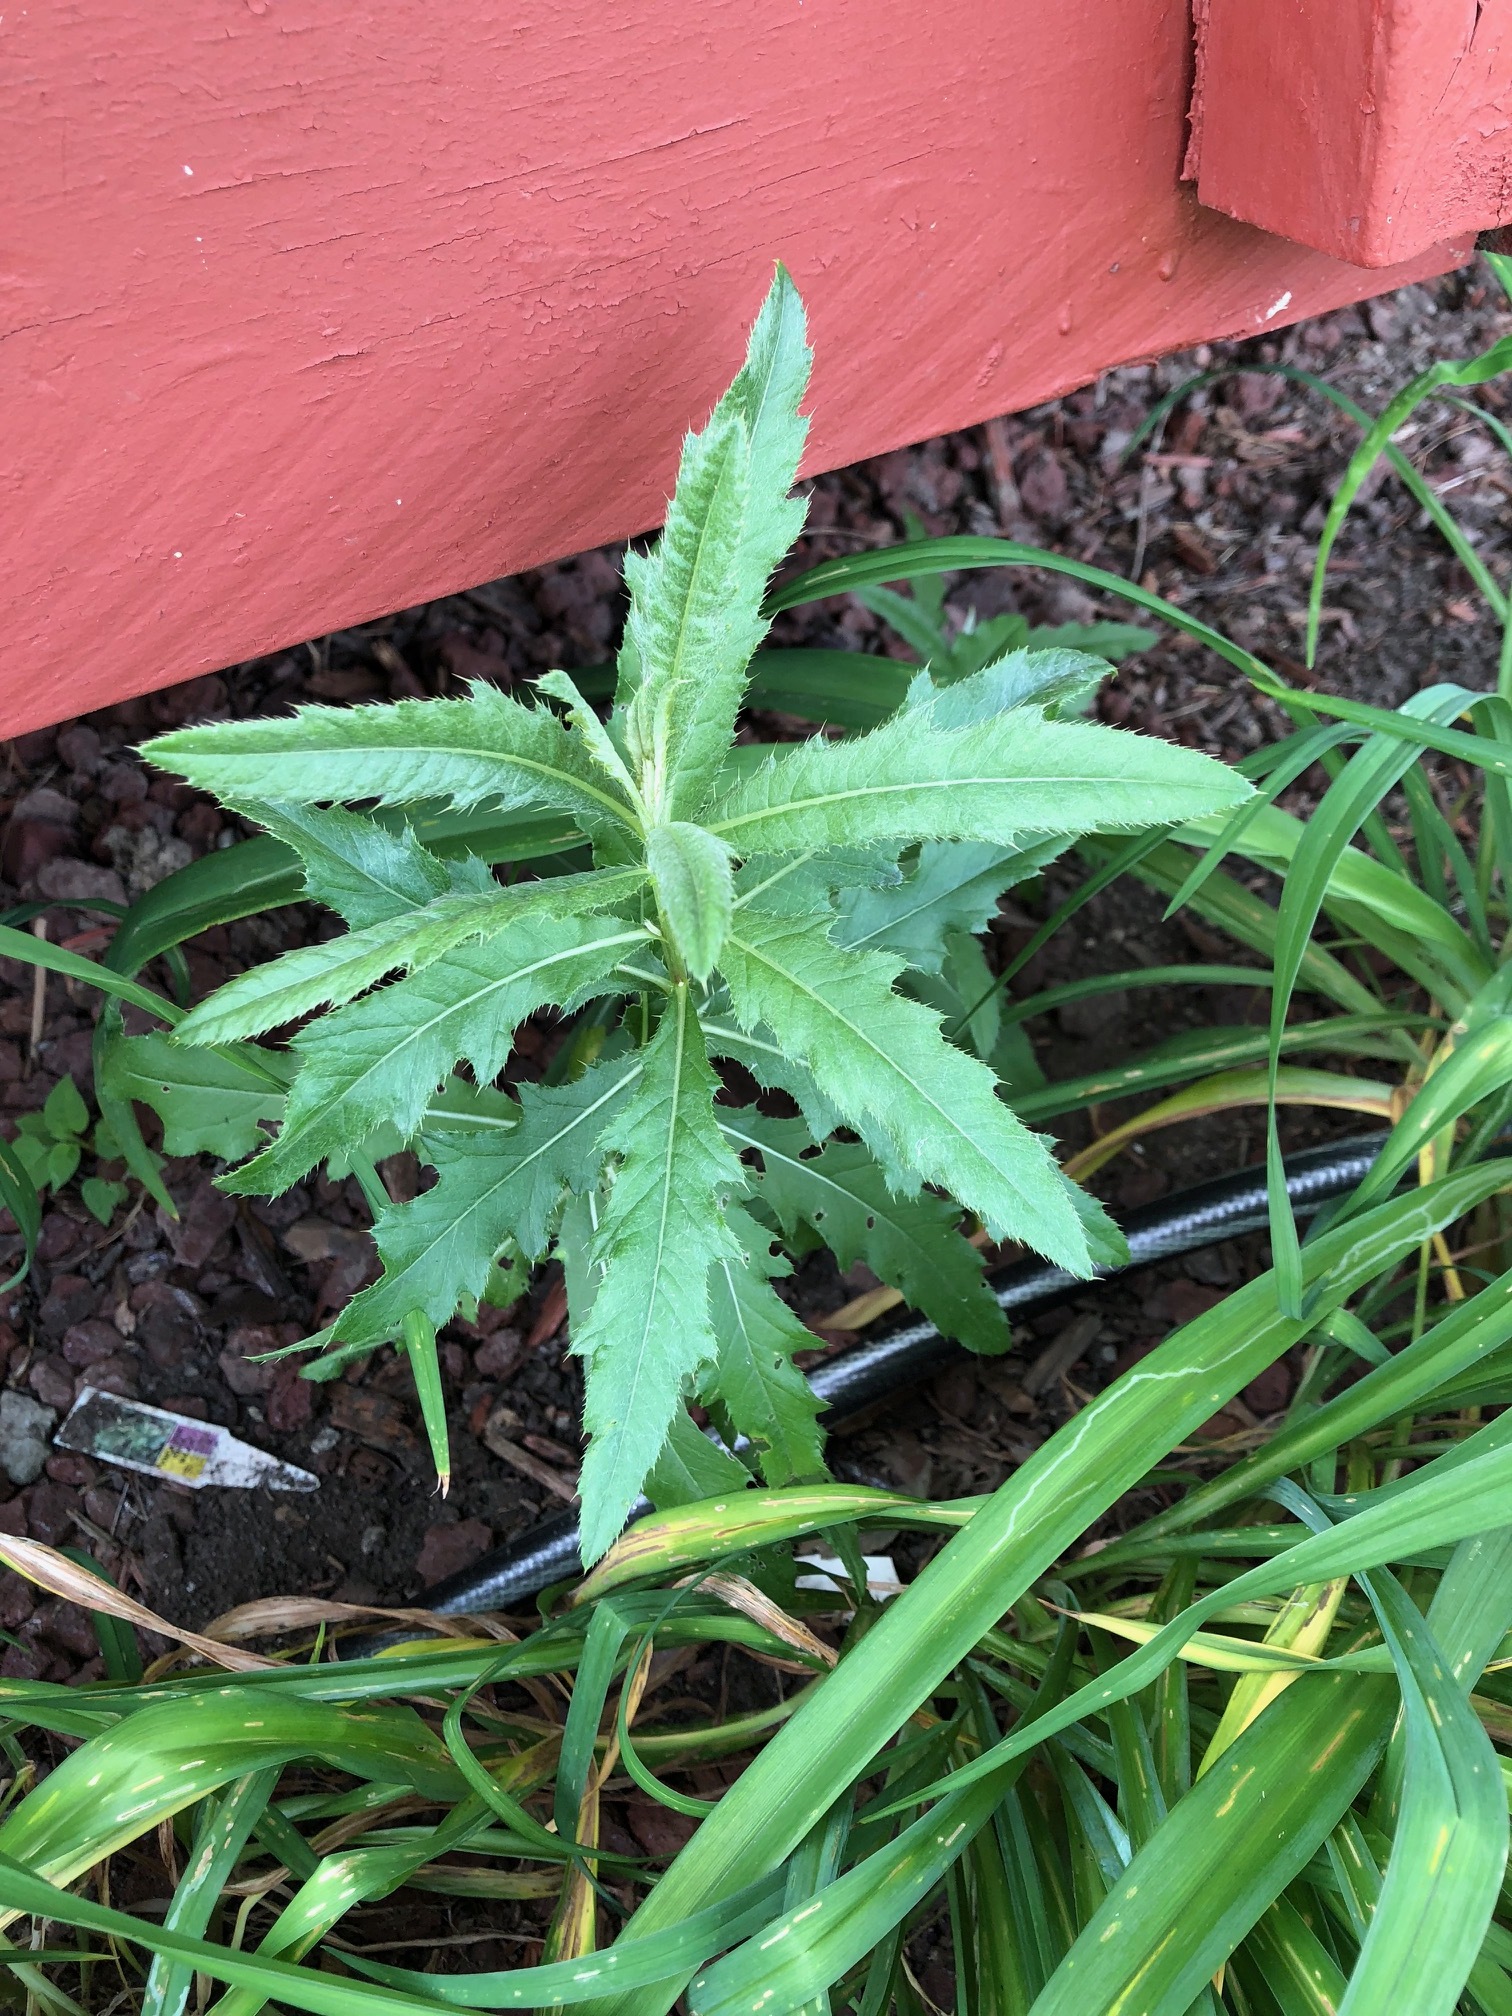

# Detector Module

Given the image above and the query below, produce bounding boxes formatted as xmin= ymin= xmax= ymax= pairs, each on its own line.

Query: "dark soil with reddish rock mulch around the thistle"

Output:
xmin=0 ymin=272 xmax=1510 ymax=1685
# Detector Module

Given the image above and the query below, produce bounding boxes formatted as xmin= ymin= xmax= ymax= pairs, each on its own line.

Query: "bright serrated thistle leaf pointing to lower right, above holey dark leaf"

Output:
xmin=722 ymin=907 xmax=1091 ymax=1274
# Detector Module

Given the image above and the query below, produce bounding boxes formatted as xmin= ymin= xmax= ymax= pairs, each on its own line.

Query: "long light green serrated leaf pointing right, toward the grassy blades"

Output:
xmin=708 ymin=708 xmax=1252 ymax=855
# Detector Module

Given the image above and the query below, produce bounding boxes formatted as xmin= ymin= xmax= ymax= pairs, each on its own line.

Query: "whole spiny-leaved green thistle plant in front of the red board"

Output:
xmin=130 ymin=274 xmax=1250 ymax=1560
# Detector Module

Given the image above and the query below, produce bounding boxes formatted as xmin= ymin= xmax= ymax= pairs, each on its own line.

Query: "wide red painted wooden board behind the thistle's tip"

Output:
xmin=0 ymin=0 xmax=1460 ymax=734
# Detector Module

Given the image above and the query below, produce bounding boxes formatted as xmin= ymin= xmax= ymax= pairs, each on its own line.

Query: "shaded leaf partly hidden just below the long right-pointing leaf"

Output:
xmin=831 ymin=839 xmax=1066 ymax=974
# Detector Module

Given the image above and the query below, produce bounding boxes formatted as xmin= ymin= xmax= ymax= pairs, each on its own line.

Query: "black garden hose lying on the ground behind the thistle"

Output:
xmin=413 ymin=1133 xmax=1387 ymax=1617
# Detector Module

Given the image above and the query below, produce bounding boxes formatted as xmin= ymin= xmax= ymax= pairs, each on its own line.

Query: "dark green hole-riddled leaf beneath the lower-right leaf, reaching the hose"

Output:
xmin=720 ymin=1107 xmax=1008 ymax=1351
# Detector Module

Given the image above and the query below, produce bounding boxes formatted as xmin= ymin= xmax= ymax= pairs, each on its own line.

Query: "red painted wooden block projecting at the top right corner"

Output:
xmin=1187 ymin=0 xmax=1512 ymax=266
